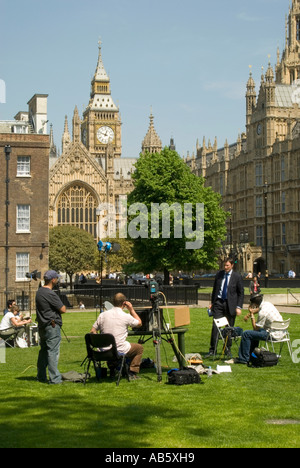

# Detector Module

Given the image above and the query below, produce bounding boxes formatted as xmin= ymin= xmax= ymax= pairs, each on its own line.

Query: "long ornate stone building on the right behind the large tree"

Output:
xmin=187 ymin=0 xmax=300 ymax=274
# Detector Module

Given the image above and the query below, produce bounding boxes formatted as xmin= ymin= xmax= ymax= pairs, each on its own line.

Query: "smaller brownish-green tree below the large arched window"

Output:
xmin=49 ymin=226 xmax=97 ymax=287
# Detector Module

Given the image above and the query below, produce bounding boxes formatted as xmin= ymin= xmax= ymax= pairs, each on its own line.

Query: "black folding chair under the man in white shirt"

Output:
xmin=81 ymin=333 xmax=129 ymax=386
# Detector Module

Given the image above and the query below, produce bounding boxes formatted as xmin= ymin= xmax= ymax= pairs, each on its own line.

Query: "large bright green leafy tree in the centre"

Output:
xmin=128 ymin=148 xmax=227 ymax=283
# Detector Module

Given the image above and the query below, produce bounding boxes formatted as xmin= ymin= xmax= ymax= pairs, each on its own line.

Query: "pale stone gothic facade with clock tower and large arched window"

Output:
xmin=49 ymin=44 xmax=162 ymax=238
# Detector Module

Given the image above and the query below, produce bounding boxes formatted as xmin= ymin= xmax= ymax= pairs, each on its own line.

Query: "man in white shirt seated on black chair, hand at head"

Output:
xmin=91 ymin=293 xmax=144 ymax=380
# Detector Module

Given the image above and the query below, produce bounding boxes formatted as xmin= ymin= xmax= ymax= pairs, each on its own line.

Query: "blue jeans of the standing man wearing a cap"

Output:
xmin=37 ymin=325 xmax=62 ymax=384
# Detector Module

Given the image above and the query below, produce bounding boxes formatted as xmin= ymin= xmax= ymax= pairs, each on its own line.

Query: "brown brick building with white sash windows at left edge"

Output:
xmin=0 ymin=95 xmax=50 ymax=310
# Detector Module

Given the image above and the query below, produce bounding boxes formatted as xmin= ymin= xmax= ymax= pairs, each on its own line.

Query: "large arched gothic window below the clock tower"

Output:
xmin=57 ymin=185 xmax=97 ymax=239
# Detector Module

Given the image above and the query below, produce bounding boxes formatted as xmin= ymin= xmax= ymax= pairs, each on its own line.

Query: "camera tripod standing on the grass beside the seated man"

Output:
xmin=139 ymin=293 xmax=180 ymax=382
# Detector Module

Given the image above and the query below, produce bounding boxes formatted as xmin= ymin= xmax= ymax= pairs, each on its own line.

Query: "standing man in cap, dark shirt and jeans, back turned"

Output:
xmin=36 ymin=270 xmax=66 ymax=384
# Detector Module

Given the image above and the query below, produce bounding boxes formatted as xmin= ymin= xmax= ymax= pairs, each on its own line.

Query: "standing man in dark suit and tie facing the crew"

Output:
xmin=209 ymin=258 xmax=244 ymax=355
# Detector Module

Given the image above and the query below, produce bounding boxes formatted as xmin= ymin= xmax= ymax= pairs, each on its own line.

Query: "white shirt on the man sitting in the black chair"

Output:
xmin=93 ymin=307 xmax=139 ymax=354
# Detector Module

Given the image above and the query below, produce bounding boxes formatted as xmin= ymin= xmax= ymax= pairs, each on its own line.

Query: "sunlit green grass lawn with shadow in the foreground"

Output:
xmin=0 ymin=309 xmax=300 ymax=449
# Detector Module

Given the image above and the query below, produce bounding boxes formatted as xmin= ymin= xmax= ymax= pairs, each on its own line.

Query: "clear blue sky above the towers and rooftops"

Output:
xmin=0 ymin=0 xmax=290 ymax=157
